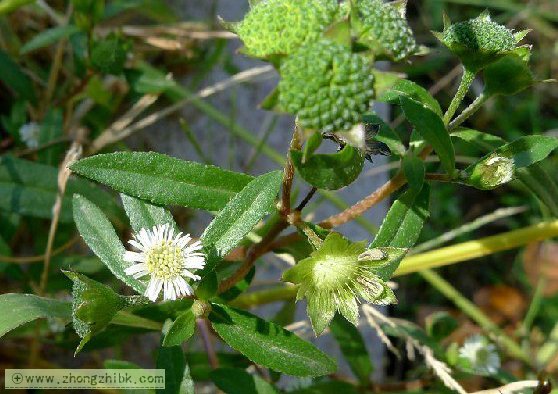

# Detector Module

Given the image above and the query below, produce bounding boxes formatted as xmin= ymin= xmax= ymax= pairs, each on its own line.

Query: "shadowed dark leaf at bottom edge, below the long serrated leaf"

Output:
xmin=210 ymin=368 xmax=277 ymax=394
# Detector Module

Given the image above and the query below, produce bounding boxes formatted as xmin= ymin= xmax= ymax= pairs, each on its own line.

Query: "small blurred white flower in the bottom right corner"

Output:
xmin=459 ymin=335 xmax=500 ymax=375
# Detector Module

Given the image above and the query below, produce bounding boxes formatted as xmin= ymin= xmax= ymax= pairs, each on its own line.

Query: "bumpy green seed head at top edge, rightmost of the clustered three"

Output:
xmin=356 ymin=0 xmax=418 ymax=61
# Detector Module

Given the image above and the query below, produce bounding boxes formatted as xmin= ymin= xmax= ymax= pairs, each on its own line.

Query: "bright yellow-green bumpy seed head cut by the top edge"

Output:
xmin=234 ymin=0 xmax=338 ymax=57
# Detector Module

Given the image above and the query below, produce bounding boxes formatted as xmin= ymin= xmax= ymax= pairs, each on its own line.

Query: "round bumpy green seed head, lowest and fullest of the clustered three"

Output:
xmin=279 ymin=40 xmax=374 ymax=132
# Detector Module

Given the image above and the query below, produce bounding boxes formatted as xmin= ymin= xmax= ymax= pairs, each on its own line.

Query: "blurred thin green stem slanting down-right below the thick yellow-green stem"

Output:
xmin=419 ymin=270 xmax=531 ymax=364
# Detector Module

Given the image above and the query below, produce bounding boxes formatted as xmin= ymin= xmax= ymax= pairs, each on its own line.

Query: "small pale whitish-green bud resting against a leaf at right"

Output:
xmin=467 ymin=154 xmax=515 ymax=190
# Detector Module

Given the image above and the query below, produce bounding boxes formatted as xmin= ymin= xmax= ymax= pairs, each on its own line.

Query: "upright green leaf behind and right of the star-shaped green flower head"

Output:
xmin=371 ymin=184 xmax=436 ymax=280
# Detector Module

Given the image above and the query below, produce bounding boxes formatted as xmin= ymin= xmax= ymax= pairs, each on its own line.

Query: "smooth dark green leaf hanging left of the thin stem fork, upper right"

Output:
xmin=400 ymin=97 xmax=455 ymax=176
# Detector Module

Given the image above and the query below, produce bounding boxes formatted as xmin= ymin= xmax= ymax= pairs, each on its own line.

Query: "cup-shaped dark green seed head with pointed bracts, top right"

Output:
xmin=434 ymin=12 xmax=528 ymax=71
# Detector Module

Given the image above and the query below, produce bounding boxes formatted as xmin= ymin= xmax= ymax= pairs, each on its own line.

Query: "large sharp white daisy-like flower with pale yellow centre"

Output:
xmin=124 ymin=223 xmax=205 ymax=301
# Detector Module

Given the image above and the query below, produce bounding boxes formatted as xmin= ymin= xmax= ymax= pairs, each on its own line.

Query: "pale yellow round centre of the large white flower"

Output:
xmin=146 ymin=240 xmax=184 ymax=280
